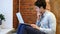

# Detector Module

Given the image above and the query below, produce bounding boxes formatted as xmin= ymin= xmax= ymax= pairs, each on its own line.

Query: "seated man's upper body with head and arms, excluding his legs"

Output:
xmin=31 ymin=0 xmax=56 ymax=34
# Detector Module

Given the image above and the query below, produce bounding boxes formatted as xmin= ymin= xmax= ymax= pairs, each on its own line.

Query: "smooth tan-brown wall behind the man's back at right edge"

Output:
xmin=50 ymin=0 xmax=60 ymax=34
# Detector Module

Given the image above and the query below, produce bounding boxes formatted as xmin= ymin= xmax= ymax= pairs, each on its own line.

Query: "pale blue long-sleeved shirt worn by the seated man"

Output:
xmin=36 ymin=10 xmax=56 ymax=34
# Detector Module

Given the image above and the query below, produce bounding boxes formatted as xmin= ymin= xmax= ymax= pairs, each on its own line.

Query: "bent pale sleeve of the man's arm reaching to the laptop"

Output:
xmin=40 ymin=15 xmax=56 ymax=33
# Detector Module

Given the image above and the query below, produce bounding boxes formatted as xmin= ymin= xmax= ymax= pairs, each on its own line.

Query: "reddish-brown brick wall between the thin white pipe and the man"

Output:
xmin=20 ymin=0 xmax=37 ymax=24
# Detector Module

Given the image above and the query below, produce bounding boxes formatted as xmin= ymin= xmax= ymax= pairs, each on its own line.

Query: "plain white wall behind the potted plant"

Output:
xmin=0 ymin=0 xmax=13 ymax=28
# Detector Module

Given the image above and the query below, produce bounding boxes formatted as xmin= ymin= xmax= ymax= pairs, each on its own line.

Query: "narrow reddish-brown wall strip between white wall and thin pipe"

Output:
xmin=13 ymin=0 xmax=19 ymax=29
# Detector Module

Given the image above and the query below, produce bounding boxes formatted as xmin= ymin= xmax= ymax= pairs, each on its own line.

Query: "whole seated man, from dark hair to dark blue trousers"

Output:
xmin=18 ymin=0 xmax=56 ymax=34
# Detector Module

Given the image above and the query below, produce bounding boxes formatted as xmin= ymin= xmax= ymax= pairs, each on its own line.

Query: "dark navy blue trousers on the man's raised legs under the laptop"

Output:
xmin=17 ymin=24 xmax=45 ymax=34
